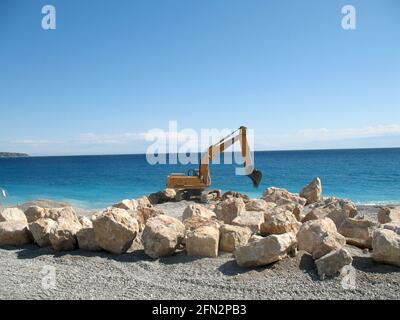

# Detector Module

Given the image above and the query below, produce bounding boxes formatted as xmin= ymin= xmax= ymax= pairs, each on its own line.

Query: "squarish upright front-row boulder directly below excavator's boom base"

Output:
xmin=186 ymin=226 xmax=219 ymax=258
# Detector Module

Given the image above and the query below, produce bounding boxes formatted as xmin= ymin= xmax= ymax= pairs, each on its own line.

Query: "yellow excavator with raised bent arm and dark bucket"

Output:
xmin=167 ymin=126 xmax=262 ymax=198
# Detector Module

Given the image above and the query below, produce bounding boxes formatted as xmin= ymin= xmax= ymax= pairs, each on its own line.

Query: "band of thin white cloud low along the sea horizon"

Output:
xmin=0 ymin=124 xmax=400 ymax=155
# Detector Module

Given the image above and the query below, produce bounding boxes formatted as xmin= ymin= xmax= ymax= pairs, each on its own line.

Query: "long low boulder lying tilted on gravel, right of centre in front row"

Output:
xmin=235 ymin=233 xmax=296 ymax=267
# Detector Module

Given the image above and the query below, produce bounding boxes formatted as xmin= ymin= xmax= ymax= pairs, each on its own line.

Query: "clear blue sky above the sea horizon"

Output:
xmin=0 ymin=0 xmax=400 ymax=155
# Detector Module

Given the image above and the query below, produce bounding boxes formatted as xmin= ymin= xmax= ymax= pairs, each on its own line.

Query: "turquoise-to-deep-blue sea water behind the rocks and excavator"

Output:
xmin=0 ymin=149 xmax=400 ymax=208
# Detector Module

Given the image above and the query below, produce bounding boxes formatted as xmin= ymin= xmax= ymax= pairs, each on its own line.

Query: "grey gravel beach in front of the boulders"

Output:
xmin=0 ymin=202 xmax=400 ymax=299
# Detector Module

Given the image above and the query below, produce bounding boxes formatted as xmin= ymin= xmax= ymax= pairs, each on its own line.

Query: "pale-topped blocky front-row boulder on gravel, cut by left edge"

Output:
xmin=0 ymin=221 xmax=31 ymax=246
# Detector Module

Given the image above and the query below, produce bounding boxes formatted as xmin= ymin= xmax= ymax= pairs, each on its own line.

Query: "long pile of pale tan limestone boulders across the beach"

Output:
xmin=0 ymin=178 xmax=400 ymax=278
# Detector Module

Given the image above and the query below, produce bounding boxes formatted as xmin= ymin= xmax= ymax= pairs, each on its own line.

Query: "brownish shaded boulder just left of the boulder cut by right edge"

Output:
xmin=338 ymin=218 xmax=379 ymax=249
